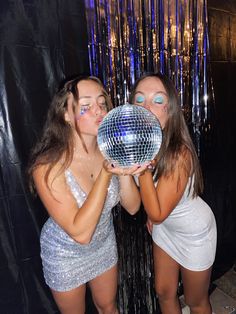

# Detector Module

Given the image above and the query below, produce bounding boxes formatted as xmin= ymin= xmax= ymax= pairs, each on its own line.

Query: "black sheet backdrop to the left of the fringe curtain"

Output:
xmin=0 ymin=0 xmax=89 ymax=314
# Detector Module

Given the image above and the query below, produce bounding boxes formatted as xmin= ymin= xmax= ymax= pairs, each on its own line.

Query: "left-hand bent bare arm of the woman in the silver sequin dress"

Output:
xmin=33 ymin=166 xmax=112 ymax=244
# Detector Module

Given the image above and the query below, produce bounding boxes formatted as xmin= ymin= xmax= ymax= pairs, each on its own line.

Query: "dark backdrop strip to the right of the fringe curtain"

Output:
xmin=203 ymin=0 xmax=236 ymax=279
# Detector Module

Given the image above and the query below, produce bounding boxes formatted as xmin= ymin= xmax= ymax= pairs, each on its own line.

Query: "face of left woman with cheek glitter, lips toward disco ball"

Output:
xmin=65 ymin=80 xmax=108 ymax=136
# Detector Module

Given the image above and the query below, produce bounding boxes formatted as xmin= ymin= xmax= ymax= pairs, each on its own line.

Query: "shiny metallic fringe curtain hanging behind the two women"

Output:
xmin=85 ymin=0 xmax=213 ymax=314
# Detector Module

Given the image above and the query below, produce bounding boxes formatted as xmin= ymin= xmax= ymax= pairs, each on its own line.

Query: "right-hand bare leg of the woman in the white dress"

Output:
xmin=181 ymin=267 xmax=212 ymax=314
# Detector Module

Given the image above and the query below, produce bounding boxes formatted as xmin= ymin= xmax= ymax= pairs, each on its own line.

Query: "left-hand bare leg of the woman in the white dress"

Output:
xmin=153 ymin=243 xmax=181 ymax=314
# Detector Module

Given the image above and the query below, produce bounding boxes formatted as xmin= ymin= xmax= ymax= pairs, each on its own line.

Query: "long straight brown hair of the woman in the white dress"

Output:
xmin=130 ymin=73 xmax=203 ymax=196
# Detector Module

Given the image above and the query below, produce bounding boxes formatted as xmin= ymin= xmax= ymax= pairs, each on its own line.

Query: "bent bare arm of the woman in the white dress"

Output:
xmin=139 ymin=152 xmax=191 ymax=223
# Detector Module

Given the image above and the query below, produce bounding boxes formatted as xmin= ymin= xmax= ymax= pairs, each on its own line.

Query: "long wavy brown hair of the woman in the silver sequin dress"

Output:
xmin=27 ymin=76 xmax=112 ymax=193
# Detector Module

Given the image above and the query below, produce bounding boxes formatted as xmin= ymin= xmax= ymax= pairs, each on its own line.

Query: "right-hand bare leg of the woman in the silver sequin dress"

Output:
xmin=89 ymin=265 xmax=119 ymax=314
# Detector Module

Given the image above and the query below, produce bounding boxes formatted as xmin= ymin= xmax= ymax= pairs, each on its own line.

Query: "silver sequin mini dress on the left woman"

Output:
xmin=40 ymin=170 xmax=119 ymax=291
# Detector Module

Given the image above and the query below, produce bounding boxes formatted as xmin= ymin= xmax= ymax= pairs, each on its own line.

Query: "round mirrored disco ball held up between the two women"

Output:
xmin=97 ymin=104 xmax=162 ymax=167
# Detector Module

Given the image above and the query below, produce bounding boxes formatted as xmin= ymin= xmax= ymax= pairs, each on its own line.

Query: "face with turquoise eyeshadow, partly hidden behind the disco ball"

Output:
xmin=134 ymin=77 xmax=169 ymax=128
